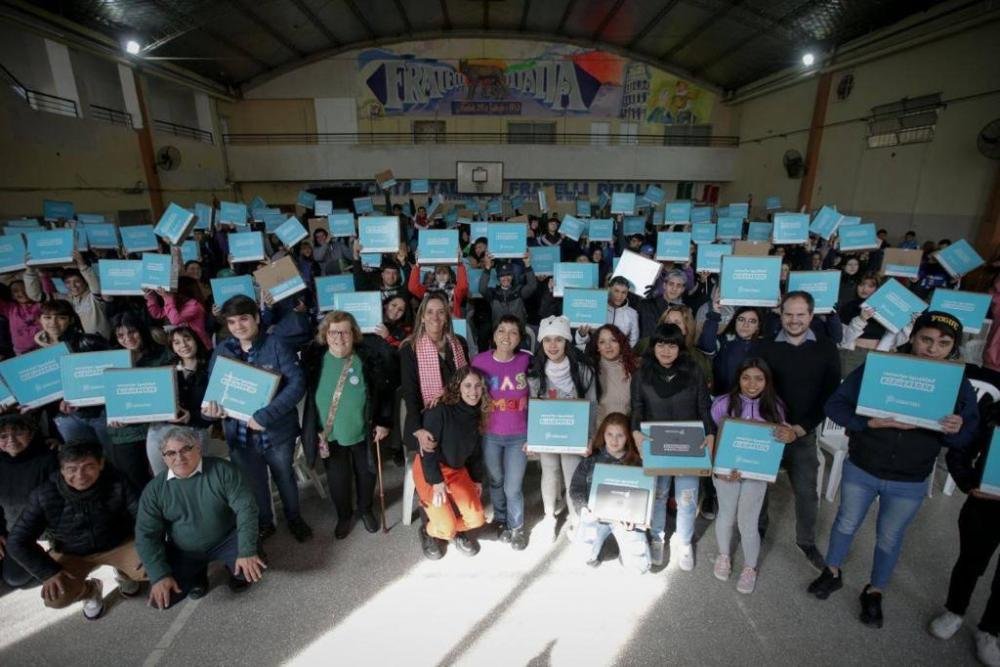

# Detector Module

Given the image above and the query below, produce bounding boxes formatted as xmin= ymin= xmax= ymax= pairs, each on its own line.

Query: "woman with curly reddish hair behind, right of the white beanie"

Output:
xmin=584 ymin=324 xmax=639 ymax=424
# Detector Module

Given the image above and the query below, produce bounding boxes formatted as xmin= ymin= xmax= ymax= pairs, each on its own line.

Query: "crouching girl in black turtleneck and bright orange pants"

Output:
xmin=413 ymin=366 xmax=491 ymax=556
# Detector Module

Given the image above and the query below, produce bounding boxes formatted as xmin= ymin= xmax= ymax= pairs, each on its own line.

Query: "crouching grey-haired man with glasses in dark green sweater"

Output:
xmin=135 ymin=426 xmax=267 ymax=609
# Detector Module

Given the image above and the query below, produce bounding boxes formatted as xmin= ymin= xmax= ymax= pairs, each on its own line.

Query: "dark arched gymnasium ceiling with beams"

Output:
xmin=21 ymin=0 xmax=941 ymax=90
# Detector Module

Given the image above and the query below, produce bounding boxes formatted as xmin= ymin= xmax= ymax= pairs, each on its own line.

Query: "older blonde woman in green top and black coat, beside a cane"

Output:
xmin=302 ymin=310 xmax=392 ymax=540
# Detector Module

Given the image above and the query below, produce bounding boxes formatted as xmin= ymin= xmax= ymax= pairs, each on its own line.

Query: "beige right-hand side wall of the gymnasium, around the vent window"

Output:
xmin=723 ymin=21 xmax=1000 ymax=245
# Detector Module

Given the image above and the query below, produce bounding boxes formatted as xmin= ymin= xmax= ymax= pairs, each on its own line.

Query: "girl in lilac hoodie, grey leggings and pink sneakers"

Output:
xmin=712 ymin=357 xmax=795 ymax=595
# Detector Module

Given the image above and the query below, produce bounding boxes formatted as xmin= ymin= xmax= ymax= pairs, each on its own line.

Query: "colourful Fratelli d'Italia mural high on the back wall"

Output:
xmin=357 ymin=40 xmax=715 ymax=125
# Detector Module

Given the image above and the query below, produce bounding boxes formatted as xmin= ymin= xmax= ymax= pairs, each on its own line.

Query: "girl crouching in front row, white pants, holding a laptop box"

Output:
xmin=570 ymin=412 xmax=649 ymax=574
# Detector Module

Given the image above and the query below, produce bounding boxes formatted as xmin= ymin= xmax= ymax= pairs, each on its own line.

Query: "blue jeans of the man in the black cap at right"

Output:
xmin=826 ymin=459 xmax=927 ymax=589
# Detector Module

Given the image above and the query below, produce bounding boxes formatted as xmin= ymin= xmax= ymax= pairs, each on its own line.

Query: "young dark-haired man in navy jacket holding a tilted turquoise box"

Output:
xmin=202 ymin=295 xmax=312 ymax=542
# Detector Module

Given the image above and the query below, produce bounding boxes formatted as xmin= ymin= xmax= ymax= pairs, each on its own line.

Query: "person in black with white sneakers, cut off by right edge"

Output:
xmin=928 ymin=402 xmax=1000 ymax=665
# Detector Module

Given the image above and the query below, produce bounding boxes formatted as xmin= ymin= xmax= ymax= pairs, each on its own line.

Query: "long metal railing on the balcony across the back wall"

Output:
xmin=222 ymin=132 xmax=740 ymax=147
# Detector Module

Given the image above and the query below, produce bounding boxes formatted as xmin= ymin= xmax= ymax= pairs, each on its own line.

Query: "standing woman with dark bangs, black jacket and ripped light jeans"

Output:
xmin=632 ymin=324 xmax=715 ymax=571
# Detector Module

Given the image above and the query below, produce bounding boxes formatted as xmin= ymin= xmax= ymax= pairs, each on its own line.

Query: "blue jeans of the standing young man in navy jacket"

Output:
xmin=229 ymin=441 xmax=299 ymax=528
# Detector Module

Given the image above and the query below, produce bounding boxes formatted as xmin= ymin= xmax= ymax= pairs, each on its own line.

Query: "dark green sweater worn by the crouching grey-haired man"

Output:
xmin=135 ymin=456 xmax=257 ymax=583
